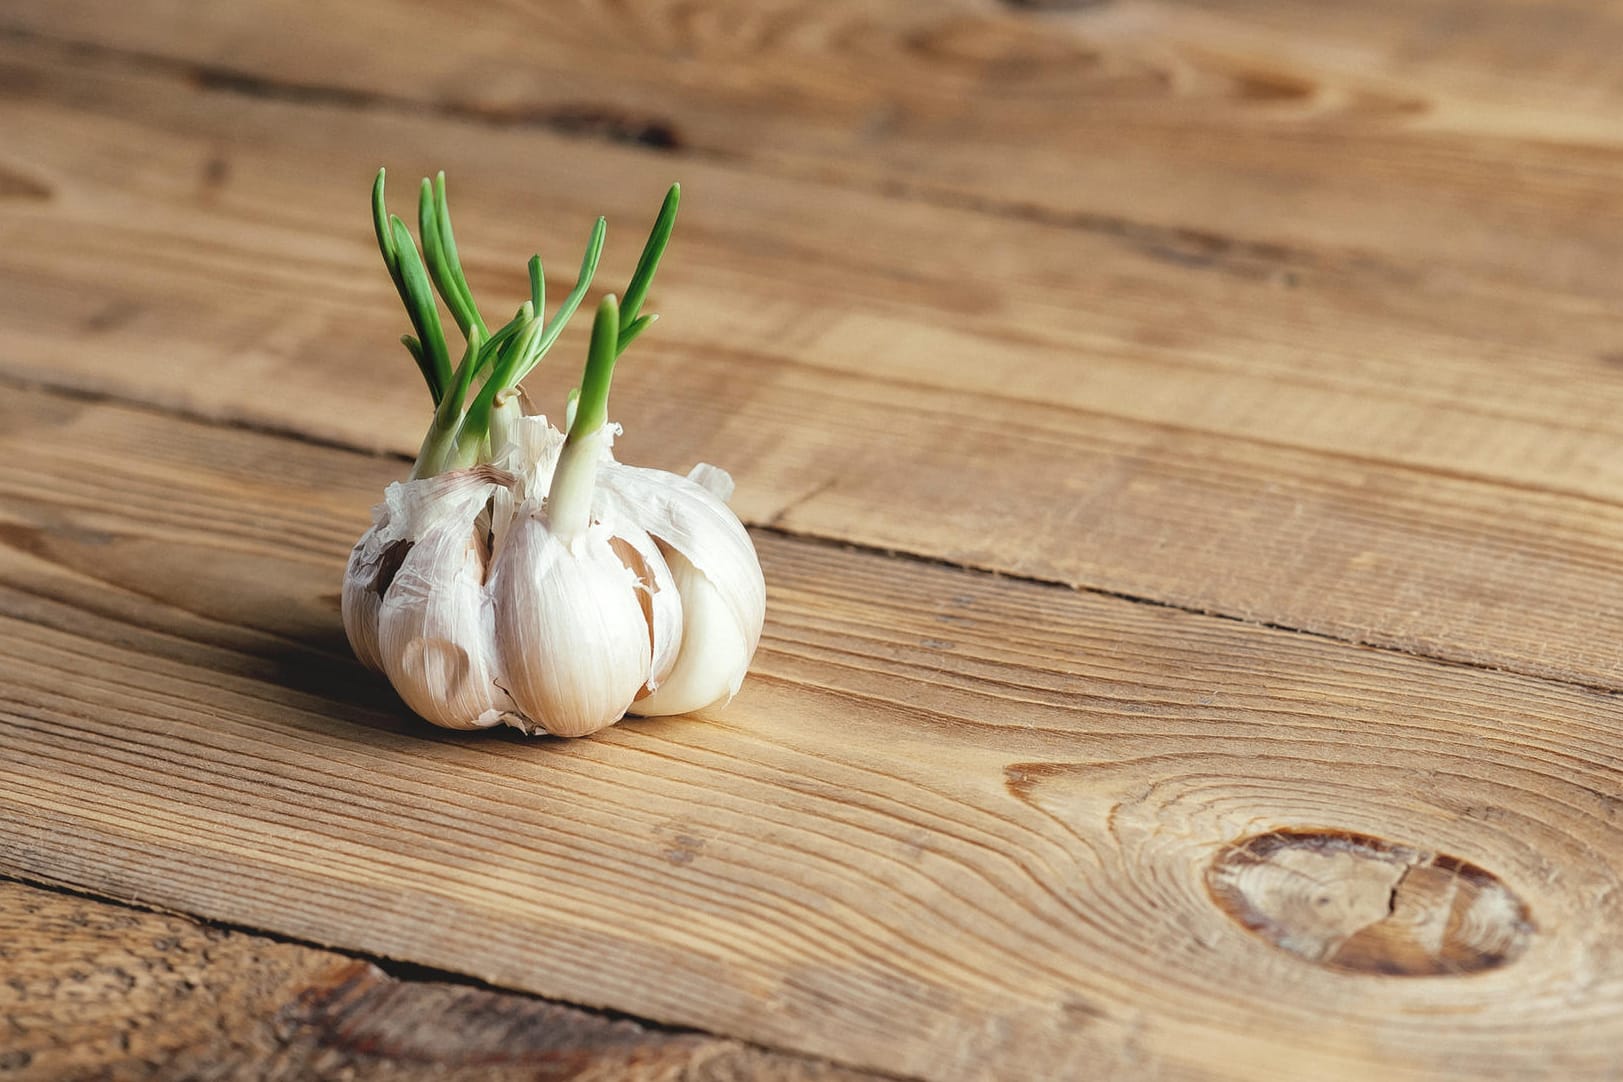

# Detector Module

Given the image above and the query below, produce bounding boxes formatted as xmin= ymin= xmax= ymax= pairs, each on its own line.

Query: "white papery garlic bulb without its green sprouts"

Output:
xmin=342 ymin=417 xmax=766 ymax=736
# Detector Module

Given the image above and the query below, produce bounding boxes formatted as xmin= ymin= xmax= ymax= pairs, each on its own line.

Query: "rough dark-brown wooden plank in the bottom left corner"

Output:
xmin=0 ymin=881 xmax=873 ymax=1082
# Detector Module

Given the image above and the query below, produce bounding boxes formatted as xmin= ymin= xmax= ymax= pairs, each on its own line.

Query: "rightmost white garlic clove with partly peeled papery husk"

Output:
xmin=596 ymin=461 xmax=766 ymax=717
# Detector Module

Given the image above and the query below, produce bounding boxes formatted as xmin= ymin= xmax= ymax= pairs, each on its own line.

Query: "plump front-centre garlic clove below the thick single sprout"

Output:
xmin=490 ymin=505 xmax=652 ymax=736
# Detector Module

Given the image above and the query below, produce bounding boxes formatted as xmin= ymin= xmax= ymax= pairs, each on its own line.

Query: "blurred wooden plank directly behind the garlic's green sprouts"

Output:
xmin=0 ymin=44 xmax=1623 ymax=688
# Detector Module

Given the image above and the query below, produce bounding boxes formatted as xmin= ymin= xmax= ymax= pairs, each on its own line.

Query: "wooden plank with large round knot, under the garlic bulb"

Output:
xmin=0 ymin=384 xmax=1623 ymax=1080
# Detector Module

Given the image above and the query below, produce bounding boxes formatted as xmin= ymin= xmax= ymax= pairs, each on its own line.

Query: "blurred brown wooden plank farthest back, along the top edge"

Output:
xmin=5 ymin=0 xmax=1623 ymax=302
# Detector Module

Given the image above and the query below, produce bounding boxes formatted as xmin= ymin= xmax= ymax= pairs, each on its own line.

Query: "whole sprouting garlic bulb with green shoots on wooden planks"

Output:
xmin=342 ymin=172 xmax=766 ymax=736
